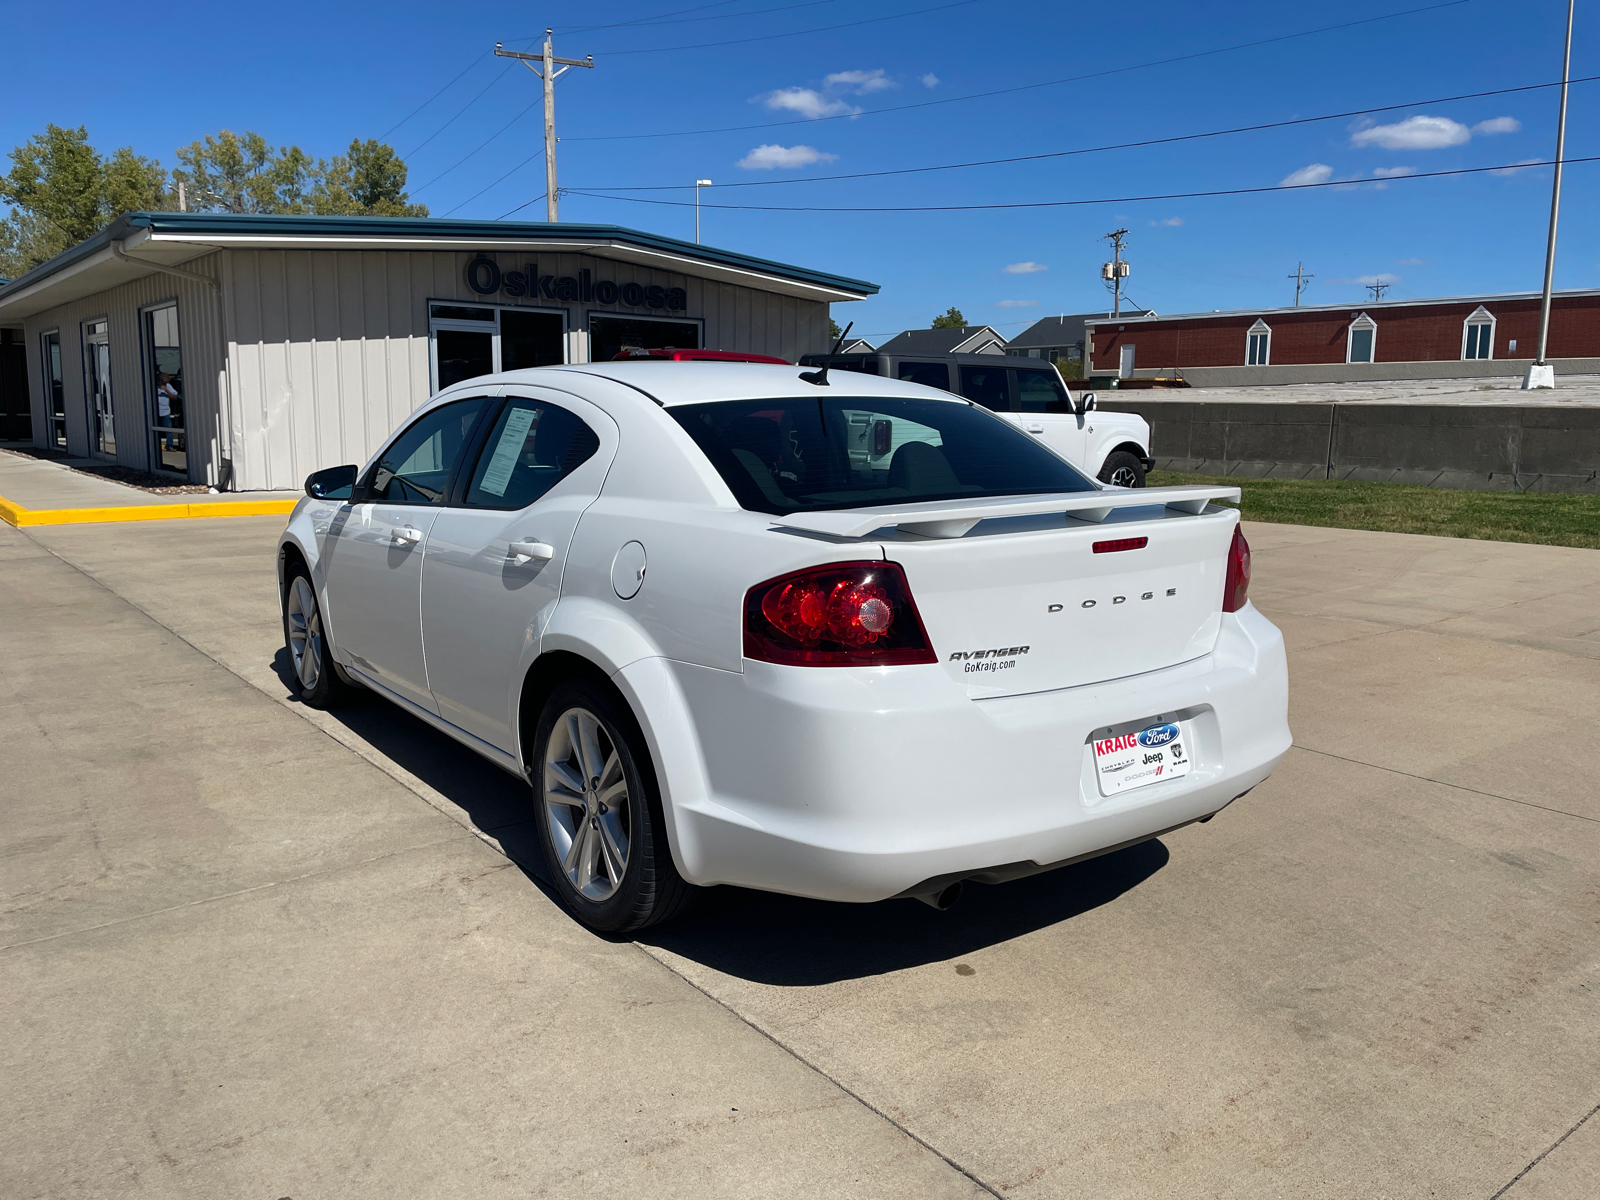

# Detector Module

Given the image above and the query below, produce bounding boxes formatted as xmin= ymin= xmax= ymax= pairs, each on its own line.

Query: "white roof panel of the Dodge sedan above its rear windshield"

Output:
xmin=489 ymin=358 xmax=968 ymax=408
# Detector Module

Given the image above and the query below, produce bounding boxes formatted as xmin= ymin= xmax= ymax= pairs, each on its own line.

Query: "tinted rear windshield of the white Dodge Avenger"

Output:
xmin=667 ymin=397 xmax=1094 ymax=515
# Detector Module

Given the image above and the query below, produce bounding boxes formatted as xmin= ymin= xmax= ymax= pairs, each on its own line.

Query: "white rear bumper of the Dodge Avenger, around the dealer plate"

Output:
xmin=619 ymin=606 xmax=1290 ymax=901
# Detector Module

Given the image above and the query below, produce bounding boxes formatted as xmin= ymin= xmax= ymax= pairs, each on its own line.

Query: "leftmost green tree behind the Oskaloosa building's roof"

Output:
xmin=0 ymin=125 xmax=171 ymax=277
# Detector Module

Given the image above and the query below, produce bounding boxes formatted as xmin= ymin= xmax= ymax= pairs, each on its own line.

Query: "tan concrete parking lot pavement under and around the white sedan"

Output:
xmin=0 ymin=517 xmax=1600 ymax=1200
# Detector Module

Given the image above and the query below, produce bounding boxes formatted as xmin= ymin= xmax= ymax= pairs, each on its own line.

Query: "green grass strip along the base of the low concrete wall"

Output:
xmin=1149 ymin=470 xmax=1600 ymax=549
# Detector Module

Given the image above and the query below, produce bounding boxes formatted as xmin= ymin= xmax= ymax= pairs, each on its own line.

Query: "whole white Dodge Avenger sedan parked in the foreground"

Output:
xmin=278 ymin=362 xmax=1290 ymax=931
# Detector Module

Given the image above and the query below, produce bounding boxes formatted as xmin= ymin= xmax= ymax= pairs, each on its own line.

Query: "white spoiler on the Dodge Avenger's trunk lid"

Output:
xmin=773 ymin=486 xmax=1240 ymax=538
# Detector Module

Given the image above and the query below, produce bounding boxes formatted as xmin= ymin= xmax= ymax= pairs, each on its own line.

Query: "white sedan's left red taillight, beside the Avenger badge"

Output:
xmin=744 ymin=562 xmax=938 ymax=667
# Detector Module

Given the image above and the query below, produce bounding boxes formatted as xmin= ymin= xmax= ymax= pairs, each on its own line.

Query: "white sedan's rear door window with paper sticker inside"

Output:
xmin=467 ymin=397 xmax=600 ymax=509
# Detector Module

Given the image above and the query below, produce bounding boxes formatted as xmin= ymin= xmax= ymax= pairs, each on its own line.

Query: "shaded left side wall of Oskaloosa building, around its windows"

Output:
xmin=24 ymin=254 xmax=226 ymax=483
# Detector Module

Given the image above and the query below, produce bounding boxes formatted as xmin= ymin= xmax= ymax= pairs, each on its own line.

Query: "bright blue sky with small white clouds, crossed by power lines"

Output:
xmin=0 ymin=0 xmax=1600 ymax=341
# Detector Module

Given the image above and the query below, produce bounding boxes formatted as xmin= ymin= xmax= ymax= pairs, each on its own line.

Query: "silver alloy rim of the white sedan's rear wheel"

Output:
xmin=544 ymin=707 xmax=630 ymax=901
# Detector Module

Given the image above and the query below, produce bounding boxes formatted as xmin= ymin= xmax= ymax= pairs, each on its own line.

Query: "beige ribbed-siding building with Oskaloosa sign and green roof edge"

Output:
xmin=0 ymin=213 xmax=878 ymax=491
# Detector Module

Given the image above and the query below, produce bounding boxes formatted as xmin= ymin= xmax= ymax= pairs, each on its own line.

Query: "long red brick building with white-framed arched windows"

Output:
xmin=1088 ymin=291 xmax=1600 ymax=384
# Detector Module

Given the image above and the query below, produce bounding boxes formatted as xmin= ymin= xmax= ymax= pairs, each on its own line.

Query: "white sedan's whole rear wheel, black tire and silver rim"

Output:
xmin=528 ymin=678 xmax=698 ymax=933
